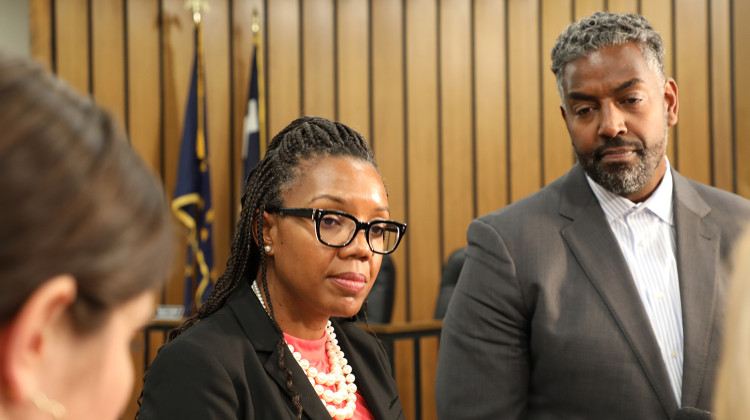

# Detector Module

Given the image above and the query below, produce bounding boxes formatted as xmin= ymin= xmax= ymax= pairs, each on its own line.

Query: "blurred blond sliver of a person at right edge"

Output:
xmin=714 ymin=227 xmax=750 ymax=420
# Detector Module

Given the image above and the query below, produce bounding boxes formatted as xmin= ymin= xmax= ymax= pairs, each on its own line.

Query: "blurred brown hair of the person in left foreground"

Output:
xmin=0 ymin=52 xmax=174 ymax=333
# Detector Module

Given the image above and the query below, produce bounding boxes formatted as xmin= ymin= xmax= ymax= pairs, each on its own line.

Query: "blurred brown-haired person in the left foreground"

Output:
xmin=0 ymin=52 xmax=174 ymax=420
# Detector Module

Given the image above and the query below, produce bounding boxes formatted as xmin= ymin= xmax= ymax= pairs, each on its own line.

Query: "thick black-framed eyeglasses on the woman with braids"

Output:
xmin=277 ymin=208 xmax=406 ymax=254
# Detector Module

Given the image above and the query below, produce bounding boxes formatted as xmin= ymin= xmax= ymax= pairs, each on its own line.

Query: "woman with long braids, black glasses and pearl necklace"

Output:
xmin=139 ymin=117 xmax=406 ymax=420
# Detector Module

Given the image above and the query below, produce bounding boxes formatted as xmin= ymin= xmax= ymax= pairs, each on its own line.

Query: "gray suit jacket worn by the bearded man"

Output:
xmin=436 ymin=165 xmax=750 ymax=420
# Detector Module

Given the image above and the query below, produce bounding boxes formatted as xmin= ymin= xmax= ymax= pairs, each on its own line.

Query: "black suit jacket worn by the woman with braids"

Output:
xmin=138 ymin=283 xmax=404 ymax=420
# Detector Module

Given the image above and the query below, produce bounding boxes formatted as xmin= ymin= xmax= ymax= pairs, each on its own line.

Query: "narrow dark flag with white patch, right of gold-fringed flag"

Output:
xmin=241 ymin=46 xmax=260 ymax=187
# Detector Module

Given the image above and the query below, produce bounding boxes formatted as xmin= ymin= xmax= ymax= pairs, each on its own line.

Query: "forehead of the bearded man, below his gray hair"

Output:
xmin=562 ymin=43 xmax=660 ymax=94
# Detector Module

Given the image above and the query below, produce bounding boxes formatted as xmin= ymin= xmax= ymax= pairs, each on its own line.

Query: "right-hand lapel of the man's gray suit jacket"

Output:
xmin=672 ymin=171 xmax=720 ymax=407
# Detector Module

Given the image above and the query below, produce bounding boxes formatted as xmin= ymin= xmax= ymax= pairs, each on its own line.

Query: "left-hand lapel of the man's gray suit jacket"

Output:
xmin=560 ymin=165 xmax=677 ymax=413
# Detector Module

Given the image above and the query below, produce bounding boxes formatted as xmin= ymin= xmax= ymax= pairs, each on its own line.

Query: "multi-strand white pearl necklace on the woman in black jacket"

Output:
xmin=252 ymin=281 xmax=357 ymax=420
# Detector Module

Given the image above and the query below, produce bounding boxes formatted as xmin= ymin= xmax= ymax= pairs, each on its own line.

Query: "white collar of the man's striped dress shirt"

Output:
xmin=586 ymin=156 xmax=673 ymax=226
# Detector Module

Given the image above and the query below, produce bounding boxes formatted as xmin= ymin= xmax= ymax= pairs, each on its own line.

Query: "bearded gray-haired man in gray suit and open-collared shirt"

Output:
xmin=436 ymin=12 xmax=750 ymax=420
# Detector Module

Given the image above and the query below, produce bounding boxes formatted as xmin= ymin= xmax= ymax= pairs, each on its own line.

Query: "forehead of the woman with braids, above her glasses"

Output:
xmin=283 ymin=156 xmax=388 ymax=207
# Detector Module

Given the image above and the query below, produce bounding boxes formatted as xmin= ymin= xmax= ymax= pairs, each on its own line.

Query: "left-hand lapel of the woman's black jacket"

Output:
xmin=227 ymin=282 xmax=330 ymax=419
